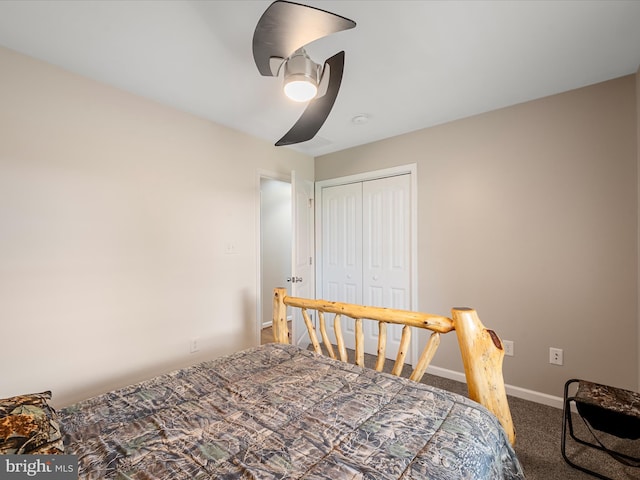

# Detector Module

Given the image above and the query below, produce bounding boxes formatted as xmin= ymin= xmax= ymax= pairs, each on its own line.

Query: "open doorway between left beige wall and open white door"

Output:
xmin=258 ymin=176 xmax=293 ymax=343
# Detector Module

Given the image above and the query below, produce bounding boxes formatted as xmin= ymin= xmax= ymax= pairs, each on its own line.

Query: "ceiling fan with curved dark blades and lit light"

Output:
xmin=253 ymin=0 xmax=356 ymax=146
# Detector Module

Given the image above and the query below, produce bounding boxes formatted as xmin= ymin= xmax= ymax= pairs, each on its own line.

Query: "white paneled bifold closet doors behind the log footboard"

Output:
xmin=322 ymin=175 xmax=411 ymax=358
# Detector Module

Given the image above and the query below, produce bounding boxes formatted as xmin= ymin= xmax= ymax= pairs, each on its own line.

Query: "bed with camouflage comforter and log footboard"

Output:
xmin=1 ymin=289 xmax=524 ymax=480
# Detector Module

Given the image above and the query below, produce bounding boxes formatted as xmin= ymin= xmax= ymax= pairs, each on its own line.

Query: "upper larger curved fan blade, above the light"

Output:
xmin=253 ymin=0 xmax=356 ymax=76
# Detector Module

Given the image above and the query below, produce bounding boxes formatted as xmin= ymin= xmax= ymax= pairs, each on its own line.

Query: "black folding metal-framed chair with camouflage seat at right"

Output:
xmin=561 ymin=378 xmax=640 ymax=480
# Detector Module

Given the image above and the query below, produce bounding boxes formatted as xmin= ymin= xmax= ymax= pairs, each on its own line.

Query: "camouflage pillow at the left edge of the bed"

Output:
xmin=0 ymin=392 xmax=64 ymax=455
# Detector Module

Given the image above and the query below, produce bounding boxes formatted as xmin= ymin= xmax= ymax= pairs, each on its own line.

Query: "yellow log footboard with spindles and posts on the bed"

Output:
xmin=273 ymin=288 xmax=516 ymax=444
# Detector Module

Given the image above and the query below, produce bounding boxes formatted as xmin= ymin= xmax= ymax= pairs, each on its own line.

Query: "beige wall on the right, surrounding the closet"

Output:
xmin=316 ymin=75 xmax=639 ymax=397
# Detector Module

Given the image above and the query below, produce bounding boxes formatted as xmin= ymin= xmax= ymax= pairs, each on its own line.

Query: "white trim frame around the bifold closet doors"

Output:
xmin=315 ymin=163 xmax=420 ymax=363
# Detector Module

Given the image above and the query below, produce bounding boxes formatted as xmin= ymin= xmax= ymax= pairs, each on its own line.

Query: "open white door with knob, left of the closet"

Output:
xmin=289 ymin=171 xmax=315 ymax=347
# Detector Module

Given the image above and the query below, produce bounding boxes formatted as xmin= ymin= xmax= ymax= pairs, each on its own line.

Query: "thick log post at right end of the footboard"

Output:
xmin=451 ymin=308 xmax=516 ymax=445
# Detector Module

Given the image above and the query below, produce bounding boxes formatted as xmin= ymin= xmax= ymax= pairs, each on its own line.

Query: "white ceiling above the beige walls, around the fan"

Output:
xmin=0 ymin=0 xmax=640 ymax=156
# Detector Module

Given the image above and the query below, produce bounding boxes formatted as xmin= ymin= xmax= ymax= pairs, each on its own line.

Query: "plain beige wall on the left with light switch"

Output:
xmin=0 ymin=48 xmax=313 ymax=406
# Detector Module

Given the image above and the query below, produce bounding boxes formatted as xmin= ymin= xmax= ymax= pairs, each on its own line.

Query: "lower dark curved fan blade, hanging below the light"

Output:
xmin=276 ymin=52 xmax=344 ymax=147
